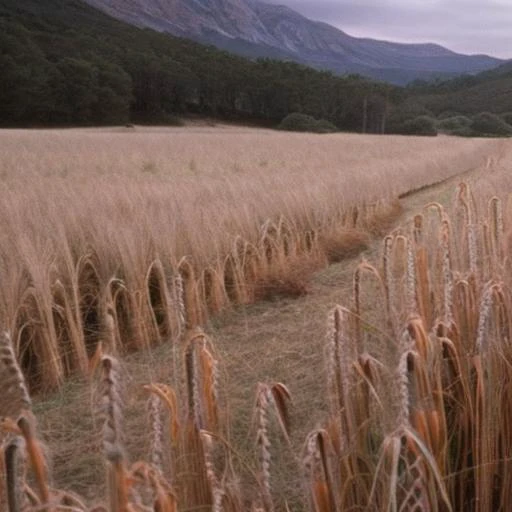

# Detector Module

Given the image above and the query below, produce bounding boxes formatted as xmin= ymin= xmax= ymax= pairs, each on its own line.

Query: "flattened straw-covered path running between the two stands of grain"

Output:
xmin=36 ymin=136 xmax=512 ymax=498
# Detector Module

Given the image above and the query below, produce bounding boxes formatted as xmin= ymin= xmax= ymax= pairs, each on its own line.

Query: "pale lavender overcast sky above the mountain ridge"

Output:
xmin=265 ymin=0 xmax=512 ymax=58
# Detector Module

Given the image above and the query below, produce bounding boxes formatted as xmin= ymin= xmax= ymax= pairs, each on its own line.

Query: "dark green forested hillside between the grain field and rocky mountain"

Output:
xmin=0 ymin=0 xmax=512 ymax=135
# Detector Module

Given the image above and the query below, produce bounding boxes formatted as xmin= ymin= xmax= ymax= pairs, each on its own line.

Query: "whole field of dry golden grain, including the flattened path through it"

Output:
xmin=0 ymin=126 xmax=512 ymax=512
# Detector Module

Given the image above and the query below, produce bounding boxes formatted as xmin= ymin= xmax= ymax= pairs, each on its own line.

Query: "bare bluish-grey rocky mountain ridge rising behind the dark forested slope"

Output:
xmin=85 ymin=0 xmax=503 ymax=84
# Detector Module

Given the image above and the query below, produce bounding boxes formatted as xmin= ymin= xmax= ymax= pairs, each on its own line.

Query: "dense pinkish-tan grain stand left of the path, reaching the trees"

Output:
xmin=0 ymin=127 xmax=499 ymax=389
